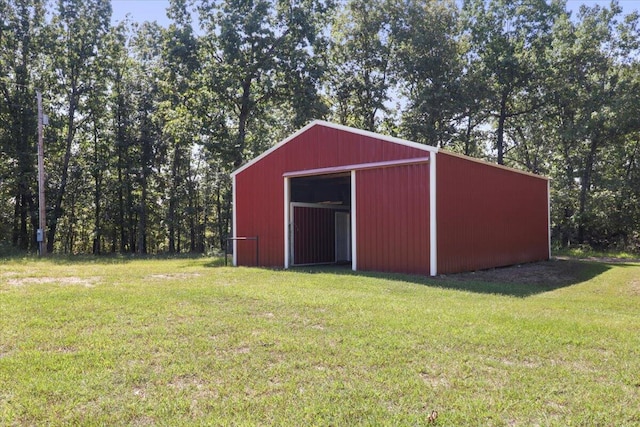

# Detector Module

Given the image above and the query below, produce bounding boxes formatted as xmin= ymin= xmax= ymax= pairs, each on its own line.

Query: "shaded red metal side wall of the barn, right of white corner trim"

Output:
xmin=436 ymin=152 xmax=549 ymax=274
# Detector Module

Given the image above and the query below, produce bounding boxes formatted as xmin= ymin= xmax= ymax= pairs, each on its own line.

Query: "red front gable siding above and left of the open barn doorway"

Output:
xmin=235 ymin=125 xmax=425 ymax=266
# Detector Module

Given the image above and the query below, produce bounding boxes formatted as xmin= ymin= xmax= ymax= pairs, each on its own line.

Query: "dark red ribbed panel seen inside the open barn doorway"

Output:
xmin=293 ymin=206 xmax=336 ymax=264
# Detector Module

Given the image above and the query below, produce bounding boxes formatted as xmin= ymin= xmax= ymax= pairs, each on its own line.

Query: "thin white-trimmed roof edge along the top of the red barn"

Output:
xmin=231 ymin=120 xmax=549 ymax=180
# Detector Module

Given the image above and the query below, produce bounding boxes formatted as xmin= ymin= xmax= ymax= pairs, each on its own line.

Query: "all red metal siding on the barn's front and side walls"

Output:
xmin=235 ymin=121 xmax=548 ymax=274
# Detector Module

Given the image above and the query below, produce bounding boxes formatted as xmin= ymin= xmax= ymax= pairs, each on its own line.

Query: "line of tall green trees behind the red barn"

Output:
xmin=0 ymin=0 xmax=640 ymax=254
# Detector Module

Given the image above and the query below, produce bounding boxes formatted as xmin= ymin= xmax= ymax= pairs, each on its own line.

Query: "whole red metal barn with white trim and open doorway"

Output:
xmin=232 ymin=121 xmax=550 ymax=276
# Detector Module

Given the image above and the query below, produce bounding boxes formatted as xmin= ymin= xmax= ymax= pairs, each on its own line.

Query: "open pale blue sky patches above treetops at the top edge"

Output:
xmin=111 ymin=0 xmax=640 ymax=26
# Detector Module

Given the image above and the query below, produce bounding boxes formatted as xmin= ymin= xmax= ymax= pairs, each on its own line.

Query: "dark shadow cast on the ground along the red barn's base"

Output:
xmin=291 ymin=260 xmax=612 ymax=298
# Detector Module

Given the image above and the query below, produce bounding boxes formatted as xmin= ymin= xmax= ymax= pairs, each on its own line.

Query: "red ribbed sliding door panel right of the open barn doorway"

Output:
xmin=356 ymin=164 xmax=429 ymax=274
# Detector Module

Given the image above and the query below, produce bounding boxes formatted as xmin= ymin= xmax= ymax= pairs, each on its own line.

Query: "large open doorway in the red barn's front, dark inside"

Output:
xmin=289 ymin=172 xmax=352 ymax=265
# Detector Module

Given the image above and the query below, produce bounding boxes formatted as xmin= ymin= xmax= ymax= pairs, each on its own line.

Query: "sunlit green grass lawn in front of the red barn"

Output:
xmin=0 ymin=258 xmax=640 ymax=426
